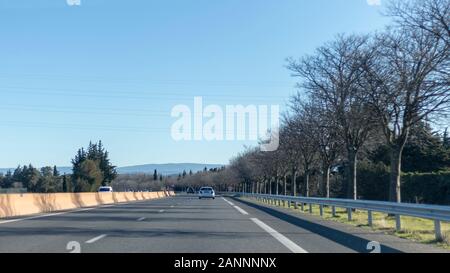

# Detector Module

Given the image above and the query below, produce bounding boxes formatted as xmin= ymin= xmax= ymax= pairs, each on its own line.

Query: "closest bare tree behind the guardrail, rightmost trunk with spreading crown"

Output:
xmin=364 ymin=25 xmax=450 ymax=202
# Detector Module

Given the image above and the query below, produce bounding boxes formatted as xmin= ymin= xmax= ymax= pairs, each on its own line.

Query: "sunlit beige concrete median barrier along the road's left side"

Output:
xmin=0 ymin=191 xmax=175 ymax=218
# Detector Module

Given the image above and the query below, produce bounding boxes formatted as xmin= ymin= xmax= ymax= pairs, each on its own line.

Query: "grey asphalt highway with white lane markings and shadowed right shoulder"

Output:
xmin=0 ymin=196 xmax=444 ymax=253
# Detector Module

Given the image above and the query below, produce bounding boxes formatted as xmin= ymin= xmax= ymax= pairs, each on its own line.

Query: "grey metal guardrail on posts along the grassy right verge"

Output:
xmin=225 ymin=193 xmax=450 ymax=241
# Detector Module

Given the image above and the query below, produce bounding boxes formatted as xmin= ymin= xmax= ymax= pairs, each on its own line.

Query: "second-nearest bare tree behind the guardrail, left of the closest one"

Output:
xmin=288 ymin=36 xmax=374 ymax=199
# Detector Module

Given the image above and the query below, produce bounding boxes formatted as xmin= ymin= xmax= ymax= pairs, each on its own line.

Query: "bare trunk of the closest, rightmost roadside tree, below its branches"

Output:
xmin=389 ymin=146 xmax=403 ymax=203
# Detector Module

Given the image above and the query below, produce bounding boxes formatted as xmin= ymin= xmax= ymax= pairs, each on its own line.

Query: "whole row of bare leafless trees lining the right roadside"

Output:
xmin=173 ymin=0 xmax=450 ymax=202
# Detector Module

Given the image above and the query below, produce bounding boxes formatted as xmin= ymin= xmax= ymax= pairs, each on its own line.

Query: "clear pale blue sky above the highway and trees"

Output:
xmin=0 ymin=0 xmax=387 ymax=167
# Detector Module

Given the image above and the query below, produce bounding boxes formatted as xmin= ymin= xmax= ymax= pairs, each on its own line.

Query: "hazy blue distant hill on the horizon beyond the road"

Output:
xmin=0 ymin=163 xmax=223 ymax=175
